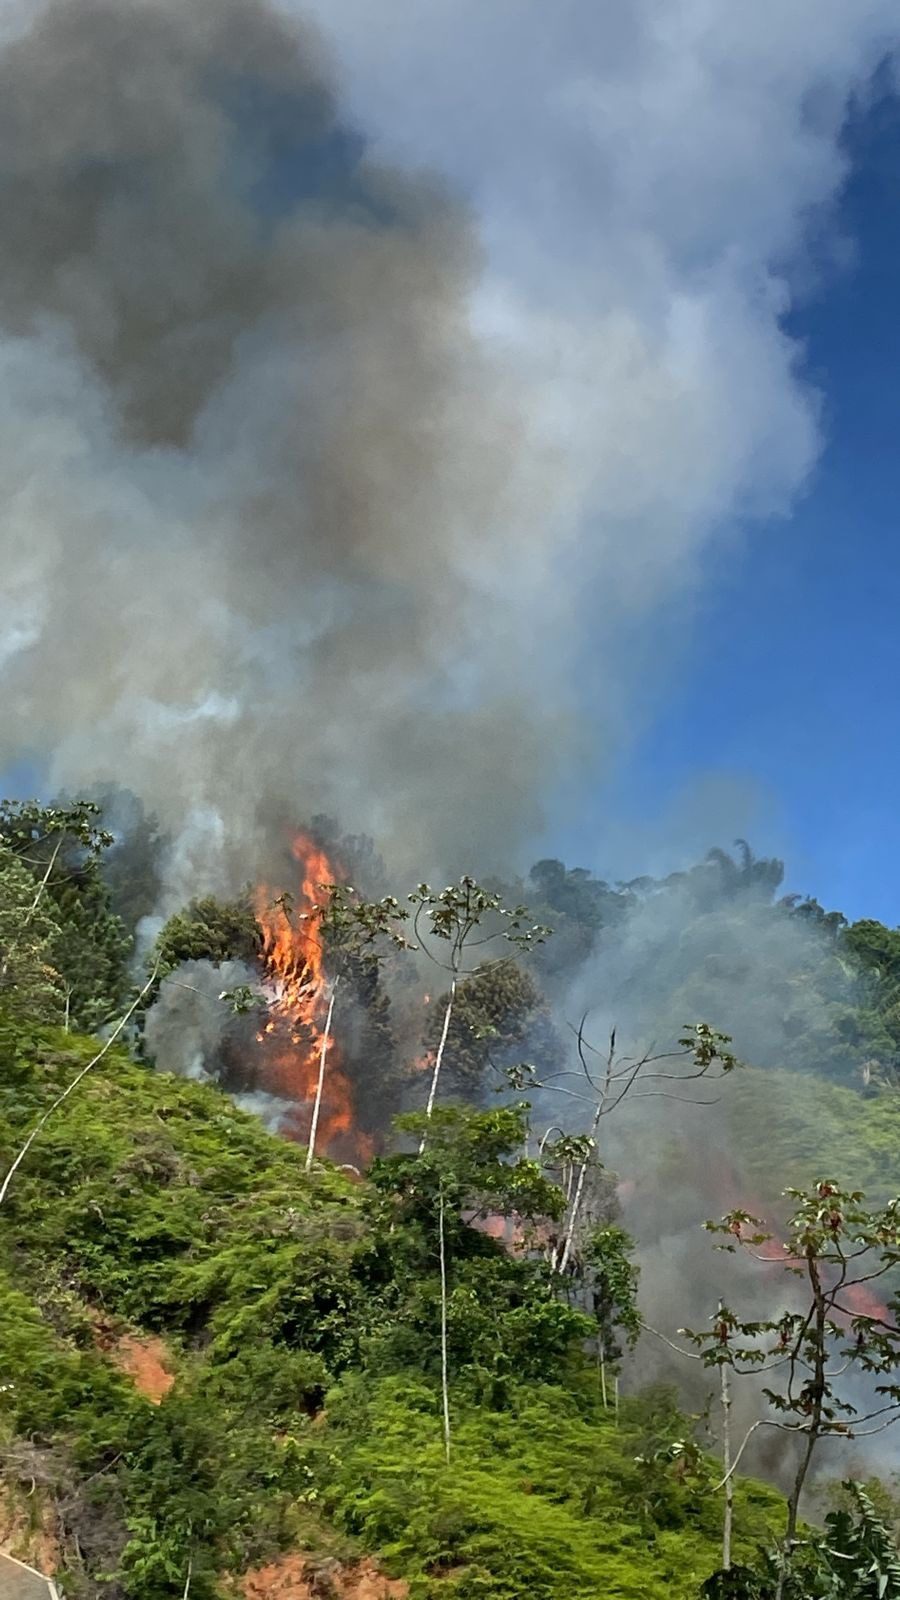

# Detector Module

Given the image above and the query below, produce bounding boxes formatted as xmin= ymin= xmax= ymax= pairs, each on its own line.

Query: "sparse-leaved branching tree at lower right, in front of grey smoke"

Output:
xmin=682 ymin=1181 xmax=900 ymax=1600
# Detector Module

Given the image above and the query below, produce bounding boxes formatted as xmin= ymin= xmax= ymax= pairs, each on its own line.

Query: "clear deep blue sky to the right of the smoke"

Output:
xmin=572 ymin=78 xmax=900 ymax=923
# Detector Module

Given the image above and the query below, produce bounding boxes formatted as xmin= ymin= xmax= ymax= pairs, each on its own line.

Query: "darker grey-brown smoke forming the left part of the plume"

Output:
xmin=0 ymin=0 xmax=563 ymax=890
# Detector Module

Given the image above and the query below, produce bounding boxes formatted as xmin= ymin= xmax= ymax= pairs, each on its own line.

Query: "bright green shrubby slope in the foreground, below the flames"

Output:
xmin=0 ymin=1027 xmax=778 ymax=1600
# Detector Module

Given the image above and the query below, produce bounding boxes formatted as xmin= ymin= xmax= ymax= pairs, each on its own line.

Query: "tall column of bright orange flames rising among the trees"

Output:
xmin=256 ymin=834 xmax=368 ymax=1160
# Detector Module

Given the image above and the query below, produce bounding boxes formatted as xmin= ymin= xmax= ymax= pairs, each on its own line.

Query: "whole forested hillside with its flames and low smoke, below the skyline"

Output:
xmin=0 ymin=792 xmax=900 ymax=1600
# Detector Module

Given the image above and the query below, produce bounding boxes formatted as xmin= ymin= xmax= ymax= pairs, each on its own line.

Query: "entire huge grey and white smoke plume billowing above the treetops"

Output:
xmin=0 ymin=0 xmax=889 ymax=909
